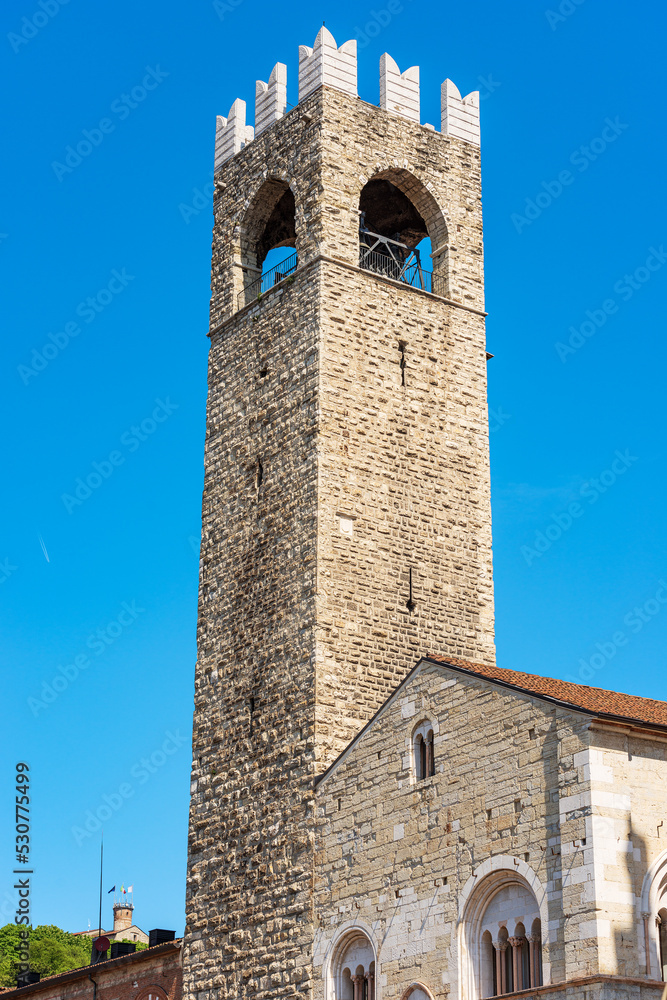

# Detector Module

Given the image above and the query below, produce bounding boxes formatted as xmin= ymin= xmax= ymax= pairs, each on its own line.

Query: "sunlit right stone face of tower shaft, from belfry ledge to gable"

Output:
xmin=316 ymin=263 xmax=494 ymax=764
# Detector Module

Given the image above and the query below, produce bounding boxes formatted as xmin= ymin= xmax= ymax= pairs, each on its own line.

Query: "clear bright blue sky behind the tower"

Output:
xmin=0 ymin=0 xmax=667 ymax=934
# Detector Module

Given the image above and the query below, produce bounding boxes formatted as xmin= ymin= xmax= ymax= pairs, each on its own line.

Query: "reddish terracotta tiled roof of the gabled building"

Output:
xmin=426 ymin=656 xmax=667 ymax=726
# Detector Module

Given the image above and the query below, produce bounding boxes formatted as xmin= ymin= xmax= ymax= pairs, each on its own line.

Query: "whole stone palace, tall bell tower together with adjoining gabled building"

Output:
xmin=183 ymin=28 xmax=667 ymax=1000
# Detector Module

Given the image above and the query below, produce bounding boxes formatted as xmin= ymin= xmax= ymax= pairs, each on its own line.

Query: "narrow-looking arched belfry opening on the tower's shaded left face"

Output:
xmin=237 ymin=178 xmax=298 ymax=308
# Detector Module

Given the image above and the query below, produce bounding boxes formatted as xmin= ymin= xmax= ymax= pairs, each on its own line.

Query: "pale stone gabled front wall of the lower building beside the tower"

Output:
xmin=314 ymin=664 xmax=598 ymax=1000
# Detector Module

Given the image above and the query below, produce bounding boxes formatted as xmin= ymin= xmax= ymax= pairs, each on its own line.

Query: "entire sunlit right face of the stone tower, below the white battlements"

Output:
xmin=316 ymin=88 xmax=495 ymax=765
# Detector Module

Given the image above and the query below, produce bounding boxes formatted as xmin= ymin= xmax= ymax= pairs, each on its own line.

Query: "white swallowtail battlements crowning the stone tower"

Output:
xmin=215 ymin=27 xmax=480 ymax=170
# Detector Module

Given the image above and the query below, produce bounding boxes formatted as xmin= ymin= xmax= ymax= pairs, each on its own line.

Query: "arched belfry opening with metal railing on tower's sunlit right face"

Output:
xmin=359 ymin=169 xmax=449 ymax=296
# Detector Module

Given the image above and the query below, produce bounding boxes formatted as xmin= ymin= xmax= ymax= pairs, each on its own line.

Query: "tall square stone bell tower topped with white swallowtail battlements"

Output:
xmin=184 ymin=28 xmax=494 ymax=1000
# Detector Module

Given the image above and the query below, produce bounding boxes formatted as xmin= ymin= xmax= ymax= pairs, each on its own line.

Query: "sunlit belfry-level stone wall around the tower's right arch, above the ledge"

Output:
xmin=311 ymin=87 xmax=484 ymax=310
